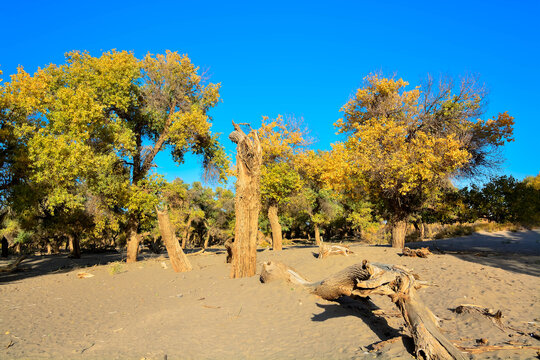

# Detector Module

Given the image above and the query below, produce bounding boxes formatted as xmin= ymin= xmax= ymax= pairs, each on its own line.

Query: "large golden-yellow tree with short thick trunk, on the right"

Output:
xmin=335 ymin=75 xmax=513 ymax=248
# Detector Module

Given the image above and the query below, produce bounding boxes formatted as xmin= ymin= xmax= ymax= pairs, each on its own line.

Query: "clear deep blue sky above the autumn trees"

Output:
xmin=0 ymin=0 xmax=540 ymax=186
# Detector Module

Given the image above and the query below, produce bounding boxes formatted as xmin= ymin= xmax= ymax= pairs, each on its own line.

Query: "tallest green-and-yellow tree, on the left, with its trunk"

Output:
xmin=3 ymin=51 xmax=228 ymax=262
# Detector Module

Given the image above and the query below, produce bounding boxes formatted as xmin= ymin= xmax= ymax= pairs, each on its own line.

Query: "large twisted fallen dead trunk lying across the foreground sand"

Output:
xmin=261 ymin=260 xmax=467 ymax=360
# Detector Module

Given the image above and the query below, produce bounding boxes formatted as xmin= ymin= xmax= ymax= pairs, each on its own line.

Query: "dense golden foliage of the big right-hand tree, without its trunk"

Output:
xmin=334 ymin=75 xmax=486 ymax=218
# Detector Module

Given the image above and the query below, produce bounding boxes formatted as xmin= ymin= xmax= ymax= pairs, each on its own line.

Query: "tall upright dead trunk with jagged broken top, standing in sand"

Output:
xmin=229 ymin=121 xmax=262 ymax=278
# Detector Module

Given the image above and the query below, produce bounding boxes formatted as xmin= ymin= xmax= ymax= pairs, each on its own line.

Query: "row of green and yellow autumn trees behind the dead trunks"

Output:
xmin=0 ymin=51 xmax=539 ymax=261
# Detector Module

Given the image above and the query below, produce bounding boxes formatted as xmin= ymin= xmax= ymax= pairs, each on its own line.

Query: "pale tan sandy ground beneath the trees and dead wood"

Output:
xmin=0 ymin=231 xmax=540 ymax=359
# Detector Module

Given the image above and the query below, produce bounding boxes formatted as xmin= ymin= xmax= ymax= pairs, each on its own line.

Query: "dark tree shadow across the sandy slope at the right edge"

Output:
xmin=405 ymin=229 xmax=540 ymax=276
